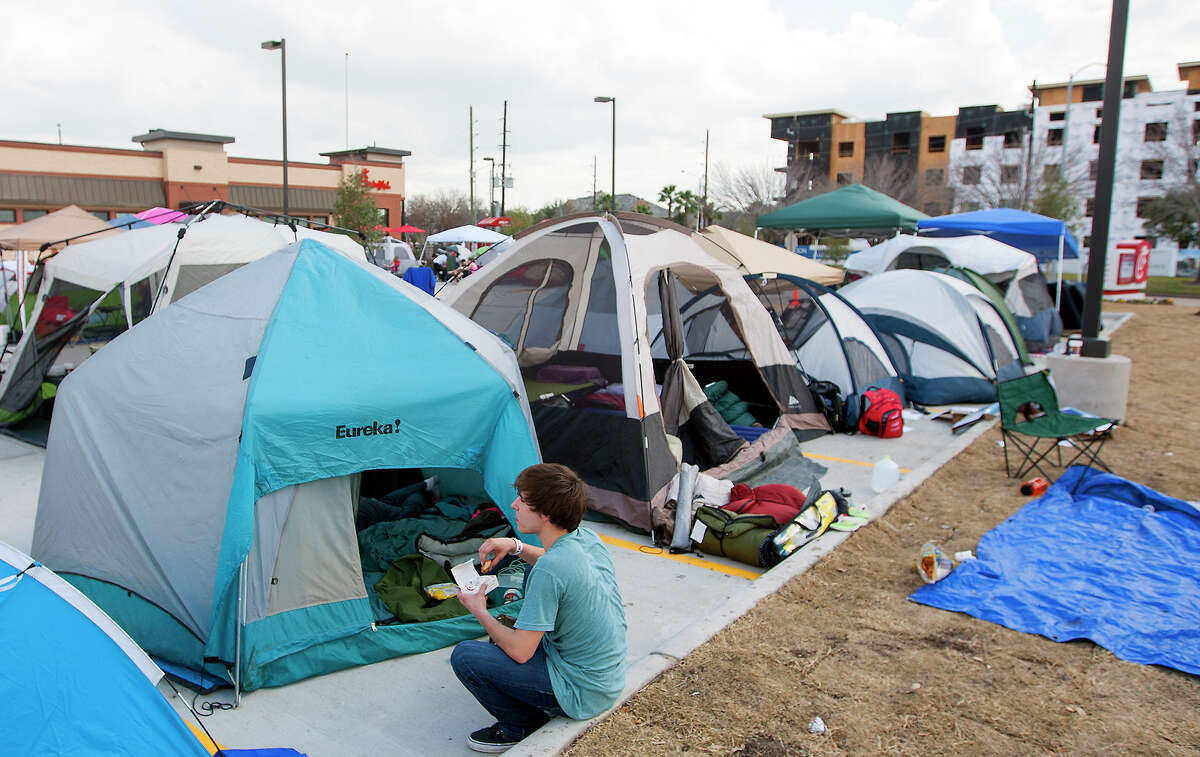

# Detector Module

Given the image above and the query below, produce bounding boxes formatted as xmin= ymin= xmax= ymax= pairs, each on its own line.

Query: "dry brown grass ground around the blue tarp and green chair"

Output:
xmin=566 ymin=305 xmax=1200 ymax=757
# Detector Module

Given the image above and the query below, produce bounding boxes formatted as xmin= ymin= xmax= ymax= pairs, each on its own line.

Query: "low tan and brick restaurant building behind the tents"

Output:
xmin=0 ymin=128 xmax=412 ymax=228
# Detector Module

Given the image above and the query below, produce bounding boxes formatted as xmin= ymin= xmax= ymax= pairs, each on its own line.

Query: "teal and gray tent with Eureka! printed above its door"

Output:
xmin=34 ymin=240 xmax=539 ymax=690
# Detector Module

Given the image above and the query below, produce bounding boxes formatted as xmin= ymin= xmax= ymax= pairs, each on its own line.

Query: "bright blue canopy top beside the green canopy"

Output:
xmin=917 ymin=208 xmax=1079 ymax=263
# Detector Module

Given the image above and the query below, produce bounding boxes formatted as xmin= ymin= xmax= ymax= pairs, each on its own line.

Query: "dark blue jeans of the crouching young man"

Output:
xmin=450 ymin=641 xmax=566 ymax=739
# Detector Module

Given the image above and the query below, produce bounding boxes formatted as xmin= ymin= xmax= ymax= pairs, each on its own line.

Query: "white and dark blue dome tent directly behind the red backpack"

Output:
xmin=746 ymin=276 xmax=905 ymax=426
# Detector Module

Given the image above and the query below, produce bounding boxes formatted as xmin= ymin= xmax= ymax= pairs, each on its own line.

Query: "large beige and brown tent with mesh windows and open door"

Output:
xmin=444 ymin=214 xmax=828 ymax=539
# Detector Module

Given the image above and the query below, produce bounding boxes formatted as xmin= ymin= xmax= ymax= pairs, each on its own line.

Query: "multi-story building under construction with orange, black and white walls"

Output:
xmin=766 ymin=61 xmax=1200 ymax=263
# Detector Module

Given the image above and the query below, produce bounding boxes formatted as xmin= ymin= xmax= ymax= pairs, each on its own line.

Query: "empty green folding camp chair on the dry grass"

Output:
xmin=997 ymin=371 xmax=1116 ymax=481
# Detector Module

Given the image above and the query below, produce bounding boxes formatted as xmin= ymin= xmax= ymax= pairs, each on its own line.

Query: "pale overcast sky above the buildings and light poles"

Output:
xmin=9 ymin=0 xmax=1200 ymax=208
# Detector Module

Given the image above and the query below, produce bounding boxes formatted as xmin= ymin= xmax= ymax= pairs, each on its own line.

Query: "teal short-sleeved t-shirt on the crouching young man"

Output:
xmin=516 ymin=528 xmax=626 ymax=720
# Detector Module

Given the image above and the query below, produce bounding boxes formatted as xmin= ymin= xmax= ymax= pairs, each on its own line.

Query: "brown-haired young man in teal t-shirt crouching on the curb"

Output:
xmin=450 ymin=463 xmax=626 ymax=752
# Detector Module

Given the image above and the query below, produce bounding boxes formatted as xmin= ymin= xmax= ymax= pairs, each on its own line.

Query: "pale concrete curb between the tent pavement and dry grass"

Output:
xmin=505 ymin=419 xmax=1000 ymax=757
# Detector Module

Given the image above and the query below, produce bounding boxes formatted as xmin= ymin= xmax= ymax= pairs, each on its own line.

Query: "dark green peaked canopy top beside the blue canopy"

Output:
xmin=758 ymin=184 xmax=929 ymax=236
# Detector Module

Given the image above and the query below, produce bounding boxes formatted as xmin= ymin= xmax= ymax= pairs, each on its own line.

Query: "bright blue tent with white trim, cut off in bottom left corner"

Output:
xmin=0 ymin=542 xmax=209 ymax=757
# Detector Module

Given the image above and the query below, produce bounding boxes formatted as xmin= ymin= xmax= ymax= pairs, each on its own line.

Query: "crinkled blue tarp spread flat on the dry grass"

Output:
xmin=908 ymin=465 xmax=1200 ymax=674
